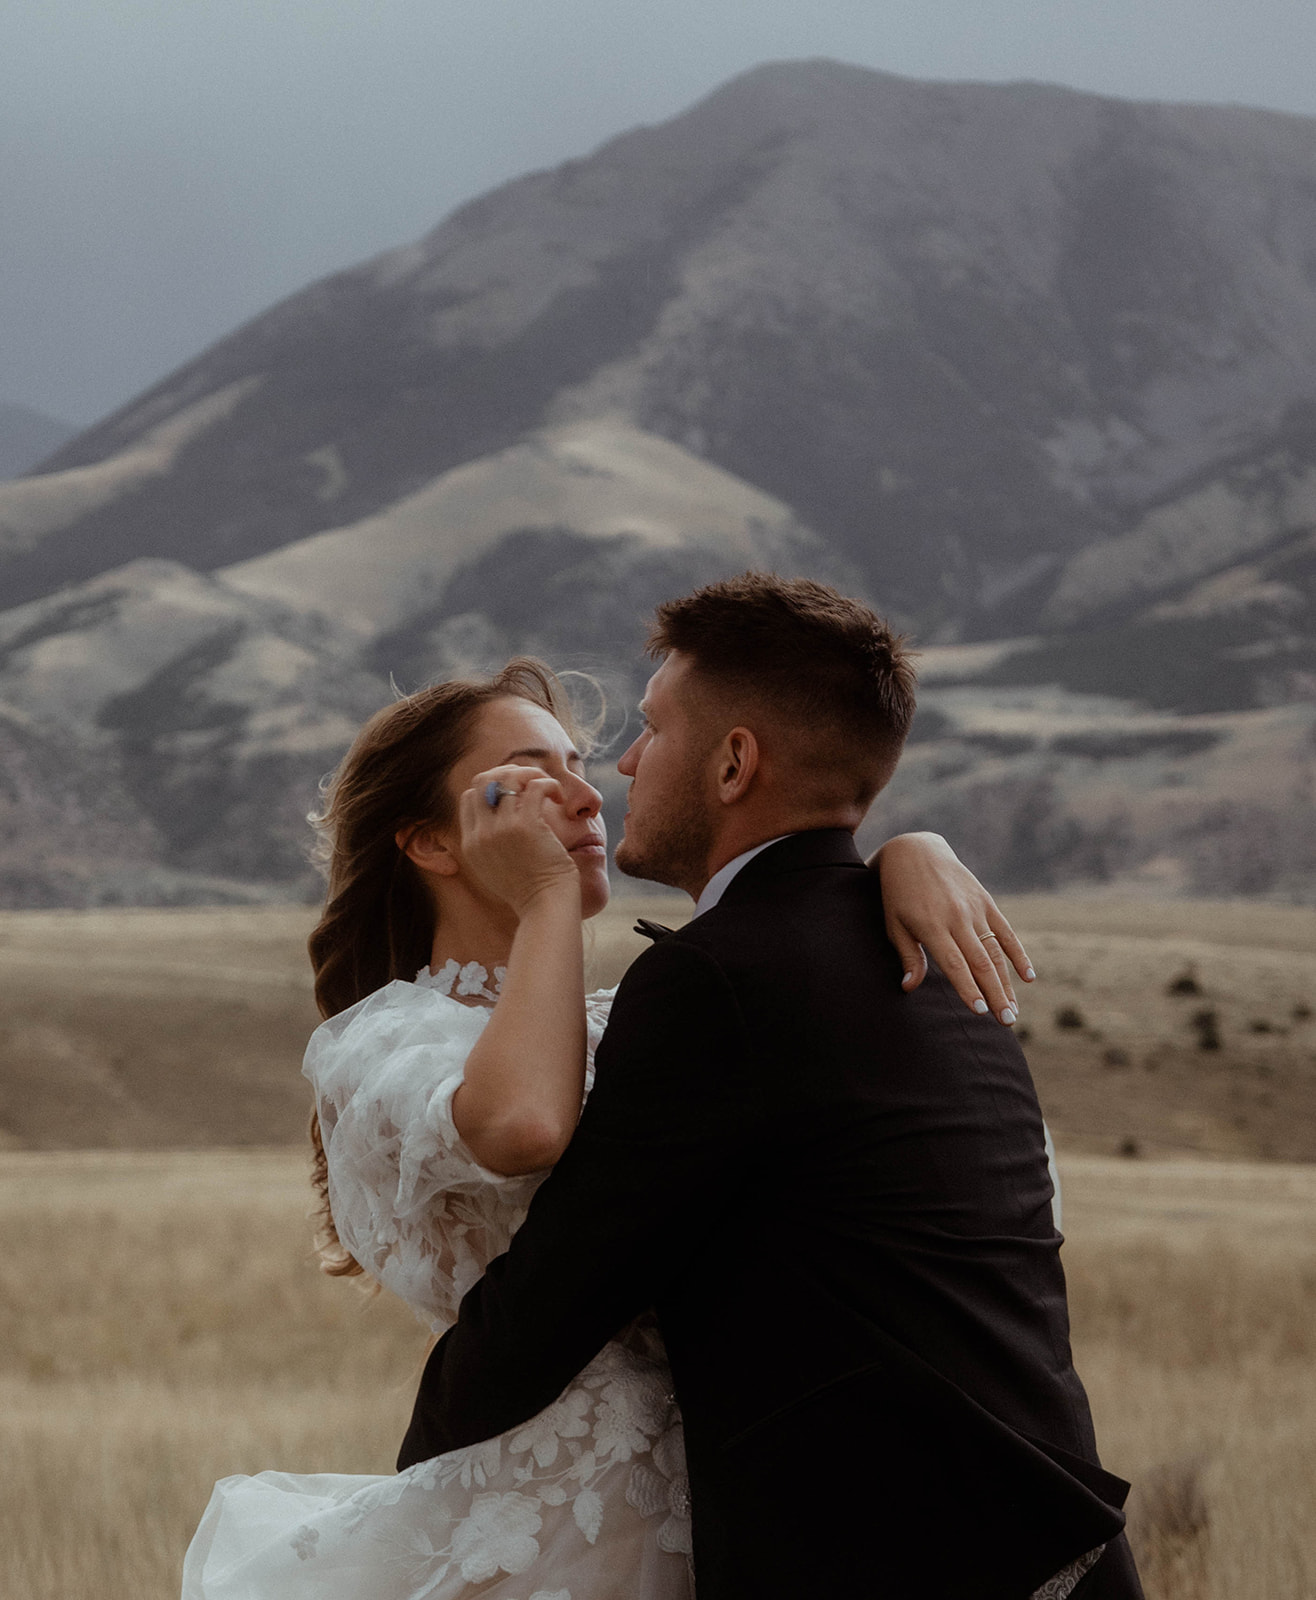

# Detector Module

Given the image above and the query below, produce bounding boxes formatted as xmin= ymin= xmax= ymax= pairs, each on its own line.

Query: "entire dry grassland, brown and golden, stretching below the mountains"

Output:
xmin=0 ymin=899 xmax=1316 ymax=1600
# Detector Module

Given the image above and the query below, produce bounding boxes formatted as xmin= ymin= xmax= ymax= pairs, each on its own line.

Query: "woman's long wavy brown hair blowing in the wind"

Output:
xmin=307 ymin=656 xmax=586 ymax=1277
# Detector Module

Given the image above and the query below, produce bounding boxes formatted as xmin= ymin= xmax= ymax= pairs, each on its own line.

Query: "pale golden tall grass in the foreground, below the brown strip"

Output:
xmin=0 ymin=1150 xmax=1316 ymax=1600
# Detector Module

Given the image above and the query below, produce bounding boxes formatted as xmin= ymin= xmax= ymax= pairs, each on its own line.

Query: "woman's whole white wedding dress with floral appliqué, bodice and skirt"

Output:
xmin=183 ymin=962 xmax=693 ymax=1600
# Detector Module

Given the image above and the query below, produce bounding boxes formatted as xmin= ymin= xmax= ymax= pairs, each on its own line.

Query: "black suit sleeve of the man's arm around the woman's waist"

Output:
xmin=399 ymin=938 xmax=762 ymax=1469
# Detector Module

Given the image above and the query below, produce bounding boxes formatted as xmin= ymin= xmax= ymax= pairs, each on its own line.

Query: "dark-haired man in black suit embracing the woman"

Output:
xmin=399 ymin=574 xmax=1141 ymax=1600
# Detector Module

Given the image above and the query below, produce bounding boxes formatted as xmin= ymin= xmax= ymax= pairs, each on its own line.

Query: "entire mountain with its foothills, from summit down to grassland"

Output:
xmin=0 ymin=61 xmax=1316 ymax=899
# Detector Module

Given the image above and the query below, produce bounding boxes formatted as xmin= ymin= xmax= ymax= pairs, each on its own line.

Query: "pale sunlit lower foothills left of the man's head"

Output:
xmin=0 ymin=426 xmax=829 ymax=904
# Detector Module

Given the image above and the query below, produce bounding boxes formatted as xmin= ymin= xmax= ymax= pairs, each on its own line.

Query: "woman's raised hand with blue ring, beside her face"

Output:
xmin=458 ymin=766 xmax=580 ymax=917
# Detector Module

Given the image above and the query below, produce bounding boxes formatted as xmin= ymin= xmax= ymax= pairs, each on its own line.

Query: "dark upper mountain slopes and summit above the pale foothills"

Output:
xmin=12 ymin=62 xmax=1316 ymax=637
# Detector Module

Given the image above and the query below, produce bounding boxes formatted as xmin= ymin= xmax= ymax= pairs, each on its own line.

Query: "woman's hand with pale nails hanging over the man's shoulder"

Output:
xmin=869 ymin=834 xmax=1036 ymax=1027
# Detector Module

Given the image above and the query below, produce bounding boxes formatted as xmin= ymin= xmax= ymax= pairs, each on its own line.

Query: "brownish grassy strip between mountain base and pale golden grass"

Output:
xmin=0 ymin=896 xmax=1316 ymax=1160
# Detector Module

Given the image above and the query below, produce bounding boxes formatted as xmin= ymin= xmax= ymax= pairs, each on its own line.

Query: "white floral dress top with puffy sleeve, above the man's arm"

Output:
xmin=303 ymin=962 xmax=613 ymax=1331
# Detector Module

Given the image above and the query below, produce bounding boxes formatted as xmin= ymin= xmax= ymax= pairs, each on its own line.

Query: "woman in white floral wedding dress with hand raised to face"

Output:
xmin=183 ymin=659 xmax=1031 ymax=1600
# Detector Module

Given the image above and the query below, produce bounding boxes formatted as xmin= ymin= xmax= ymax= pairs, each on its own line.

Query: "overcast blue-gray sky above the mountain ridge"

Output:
xmin=0 ymin=0 xmax=1316 ymax=422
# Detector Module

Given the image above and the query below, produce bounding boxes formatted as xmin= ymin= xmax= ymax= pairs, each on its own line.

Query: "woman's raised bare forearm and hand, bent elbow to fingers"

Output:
xmin=453 ymin=766 xmax=586 ymax=1176
